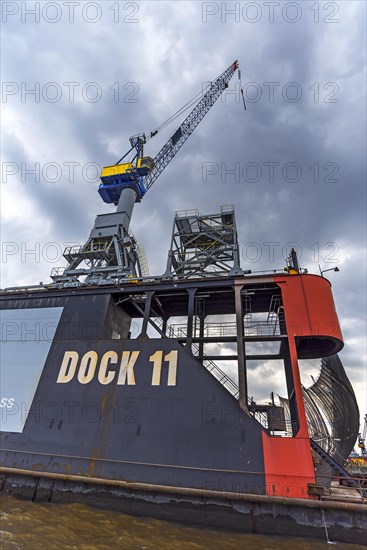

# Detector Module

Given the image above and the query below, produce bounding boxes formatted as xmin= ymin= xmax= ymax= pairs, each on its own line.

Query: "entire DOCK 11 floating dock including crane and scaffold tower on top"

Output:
xmin=0 ymin=62 xmax=366 ymax=542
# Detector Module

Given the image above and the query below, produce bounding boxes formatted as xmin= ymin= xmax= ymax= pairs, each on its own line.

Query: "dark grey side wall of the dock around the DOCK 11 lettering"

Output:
xmin=1 ymin=286 xmax=265 ymax=494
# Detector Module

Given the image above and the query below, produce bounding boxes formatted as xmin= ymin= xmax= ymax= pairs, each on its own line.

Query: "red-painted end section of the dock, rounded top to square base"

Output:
xmin=262 ymin=275 xmax=343 ymax=499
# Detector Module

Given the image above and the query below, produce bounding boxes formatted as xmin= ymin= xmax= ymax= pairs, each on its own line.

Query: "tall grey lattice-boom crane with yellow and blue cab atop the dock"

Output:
xmin=51 ymin=60 xmax=242 ymax=287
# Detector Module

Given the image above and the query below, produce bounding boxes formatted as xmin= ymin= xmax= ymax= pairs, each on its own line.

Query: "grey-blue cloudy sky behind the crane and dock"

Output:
xmin=1 ymin=0 xmax=367 ymax=420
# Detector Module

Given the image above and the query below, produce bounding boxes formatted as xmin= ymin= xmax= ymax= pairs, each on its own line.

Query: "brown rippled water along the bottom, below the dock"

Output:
xmin=0 ymin=496 xmax=364 ymax=550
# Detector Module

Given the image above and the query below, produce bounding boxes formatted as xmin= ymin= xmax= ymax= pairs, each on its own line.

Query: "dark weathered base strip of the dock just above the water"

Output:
xmin=0 ymin=473 xmax=367 ymax=545
